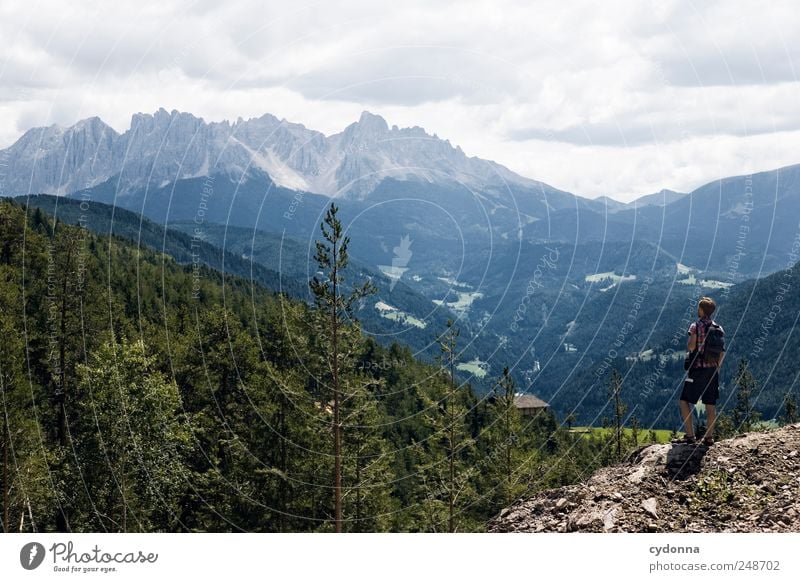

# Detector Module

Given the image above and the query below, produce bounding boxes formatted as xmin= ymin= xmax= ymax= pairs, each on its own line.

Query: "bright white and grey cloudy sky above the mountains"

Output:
xmin=0 ymin=0 xmax=800 ymax=200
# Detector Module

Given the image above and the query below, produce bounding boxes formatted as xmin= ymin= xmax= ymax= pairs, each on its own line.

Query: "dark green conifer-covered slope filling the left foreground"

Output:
xmin=0 ymin=200 xmax=612 ymax=532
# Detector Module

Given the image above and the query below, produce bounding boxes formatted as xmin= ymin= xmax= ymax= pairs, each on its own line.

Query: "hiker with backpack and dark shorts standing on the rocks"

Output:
xmin=679 ymin=297 xmax=725 ymax=446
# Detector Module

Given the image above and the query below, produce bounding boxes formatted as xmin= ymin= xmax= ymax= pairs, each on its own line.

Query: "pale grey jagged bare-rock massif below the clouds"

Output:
xmin=0 ymin=107 xmax=532 ymax=197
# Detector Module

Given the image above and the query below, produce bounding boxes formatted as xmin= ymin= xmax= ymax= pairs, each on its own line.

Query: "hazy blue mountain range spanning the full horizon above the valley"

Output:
xmin=7 ymin=109 xmax=800 ymax=277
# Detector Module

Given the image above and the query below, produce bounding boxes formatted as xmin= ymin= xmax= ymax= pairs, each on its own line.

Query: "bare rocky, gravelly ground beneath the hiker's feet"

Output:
xmin=488 ymin=424 xmax=800 ymax=532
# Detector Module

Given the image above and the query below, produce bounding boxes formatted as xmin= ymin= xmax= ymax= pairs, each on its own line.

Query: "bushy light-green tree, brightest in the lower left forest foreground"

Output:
xmin=75 ymin=341 xmax=190 ymax=532
